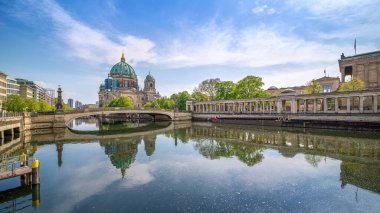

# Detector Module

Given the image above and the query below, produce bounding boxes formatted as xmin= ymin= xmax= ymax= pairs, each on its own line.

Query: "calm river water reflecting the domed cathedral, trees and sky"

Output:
xmin=0 ymin=119 xmax=380 ymax=212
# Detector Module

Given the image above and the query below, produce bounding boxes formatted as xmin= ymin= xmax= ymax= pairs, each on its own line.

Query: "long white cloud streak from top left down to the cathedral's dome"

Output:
xmin=12 ymin=0 xmax=155 ymax=64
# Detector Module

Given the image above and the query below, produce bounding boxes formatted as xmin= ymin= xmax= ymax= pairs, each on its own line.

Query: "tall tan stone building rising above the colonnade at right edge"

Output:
xmin=338 ymin=51 xmax=380 ymax=89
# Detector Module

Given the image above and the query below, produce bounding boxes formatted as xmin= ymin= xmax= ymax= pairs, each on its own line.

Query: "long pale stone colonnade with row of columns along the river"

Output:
xmin=186 ymin=90 xmax=380 ymax=114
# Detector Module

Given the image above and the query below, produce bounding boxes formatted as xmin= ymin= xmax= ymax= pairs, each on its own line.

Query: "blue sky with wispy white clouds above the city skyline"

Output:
xmin=0 ymin=0 xmax=380 ymax=103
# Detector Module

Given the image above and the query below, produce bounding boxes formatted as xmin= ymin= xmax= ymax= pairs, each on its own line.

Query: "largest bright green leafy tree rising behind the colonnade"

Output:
xmin=235 ymin=75 xmax=270 ymax=99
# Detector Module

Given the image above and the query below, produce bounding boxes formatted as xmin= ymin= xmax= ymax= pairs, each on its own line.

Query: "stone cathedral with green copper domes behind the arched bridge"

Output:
xmin=98 ymin=53 xmax=160 ymax=108
